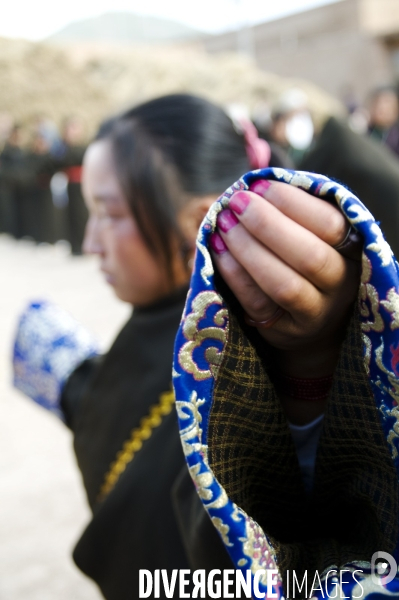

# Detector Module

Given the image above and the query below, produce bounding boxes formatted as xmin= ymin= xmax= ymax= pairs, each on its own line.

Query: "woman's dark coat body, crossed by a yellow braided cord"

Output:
xmin=62 ymin=293 xmax=231 ymax=600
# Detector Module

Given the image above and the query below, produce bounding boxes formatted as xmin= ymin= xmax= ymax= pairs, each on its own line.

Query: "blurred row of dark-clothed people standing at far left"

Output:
xmin=0 ymin=114 xmax=87 ymax=254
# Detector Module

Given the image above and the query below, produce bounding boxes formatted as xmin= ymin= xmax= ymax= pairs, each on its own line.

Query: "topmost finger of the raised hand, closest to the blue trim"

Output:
xmin=249 ymin=180 xmax=348 ymax=246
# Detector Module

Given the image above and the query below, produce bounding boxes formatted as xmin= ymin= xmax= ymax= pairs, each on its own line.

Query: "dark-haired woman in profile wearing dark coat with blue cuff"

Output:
xmin=15 ymin=95 xmax=282 ymax=600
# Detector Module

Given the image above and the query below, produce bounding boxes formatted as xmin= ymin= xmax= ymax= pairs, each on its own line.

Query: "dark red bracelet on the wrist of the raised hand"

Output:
xmin=273 ymin=373 xmax=333 ymax=401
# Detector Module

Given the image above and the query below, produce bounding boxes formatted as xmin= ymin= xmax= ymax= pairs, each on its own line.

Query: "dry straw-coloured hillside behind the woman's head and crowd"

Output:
xmin=0 ymin=38 xmax=342 ymax=135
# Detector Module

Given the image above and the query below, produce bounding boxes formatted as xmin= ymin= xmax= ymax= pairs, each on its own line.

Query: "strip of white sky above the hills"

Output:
xmin=0 ymin=0 xmax=342 ymax=40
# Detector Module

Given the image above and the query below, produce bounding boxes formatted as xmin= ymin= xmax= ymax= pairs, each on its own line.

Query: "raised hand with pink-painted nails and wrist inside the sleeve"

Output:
xmin=211 ymin=181 xmax=361 ymax=377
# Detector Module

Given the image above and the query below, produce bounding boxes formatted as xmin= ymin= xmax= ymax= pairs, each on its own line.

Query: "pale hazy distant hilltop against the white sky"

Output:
xmin=48 ymin=12 xmax=203 ymax=44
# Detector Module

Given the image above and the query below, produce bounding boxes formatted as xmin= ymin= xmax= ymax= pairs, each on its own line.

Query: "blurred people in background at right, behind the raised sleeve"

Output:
xmin=254 ymin=85 xmax=399 ymax=256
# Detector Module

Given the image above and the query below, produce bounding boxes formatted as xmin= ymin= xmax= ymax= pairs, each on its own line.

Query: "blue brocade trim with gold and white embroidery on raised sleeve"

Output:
xmin=173 ymin=168 xmax=399 ymax=600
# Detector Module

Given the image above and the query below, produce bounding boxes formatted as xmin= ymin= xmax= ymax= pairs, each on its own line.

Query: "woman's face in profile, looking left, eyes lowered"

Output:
xmin=82 ymin=140 xmax=175 ymax=306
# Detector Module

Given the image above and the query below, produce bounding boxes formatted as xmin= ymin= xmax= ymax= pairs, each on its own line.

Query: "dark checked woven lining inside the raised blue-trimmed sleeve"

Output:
xmin=208 ymin=310 xmax=398 ymax=576
